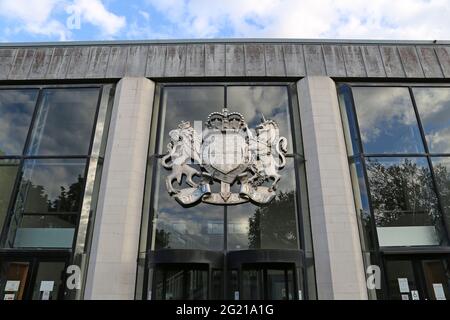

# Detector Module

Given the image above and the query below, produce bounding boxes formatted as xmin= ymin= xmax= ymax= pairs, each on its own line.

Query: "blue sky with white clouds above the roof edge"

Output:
xmin=0 ymin=0 xmax=450 ymax=42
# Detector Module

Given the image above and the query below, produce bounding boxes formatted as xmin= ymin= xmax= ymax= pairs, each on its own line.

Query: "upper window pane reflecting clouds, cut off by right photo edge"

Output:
xmin=413 ymin=88 xmax=450 ymax=153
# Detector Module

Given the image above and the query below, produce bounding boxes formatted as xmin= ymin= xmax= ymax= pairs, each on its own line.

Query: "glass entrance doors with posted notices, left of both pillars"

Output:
xmin=0 ymin=258 xmax=66 ymax=300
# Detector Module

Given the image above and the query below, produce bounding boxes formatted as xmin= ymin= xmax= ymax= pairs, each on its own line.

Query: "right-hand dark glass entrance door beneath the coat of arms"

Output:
xmin=241 ymin=264 xmax=296 ymax=300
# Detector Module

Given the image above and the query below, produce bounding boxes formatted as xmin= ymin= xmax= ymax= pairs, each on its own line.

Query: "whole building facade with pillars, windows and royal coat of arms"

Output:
xmin=0 ymin=39 xmax=450 ymax=300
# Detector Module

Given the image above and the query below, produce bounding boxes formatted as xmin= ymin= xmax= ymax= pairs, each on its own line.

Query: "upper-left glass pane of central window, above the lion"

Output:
xmin=159 ymin=86 xmax=225 ymax=153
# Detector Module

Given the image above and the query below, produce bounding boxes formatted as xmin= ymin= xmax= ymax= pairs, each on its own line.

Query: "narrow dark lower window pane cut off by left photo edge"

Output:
xmin=0 ymin=160 xmax=19 ymax=232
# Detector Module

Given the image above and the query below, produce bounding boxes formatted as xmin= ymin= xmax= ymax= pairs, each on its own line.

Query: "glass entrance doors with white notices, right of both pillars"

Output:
xmin=385 ymin=256 xmax=450 ymax=300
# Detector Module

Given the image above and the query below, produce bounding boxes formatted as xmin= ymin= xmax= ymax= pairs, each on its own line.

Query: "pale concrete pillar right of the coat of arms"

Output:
xmin=297 ymin=76 xmax=367 ymax=299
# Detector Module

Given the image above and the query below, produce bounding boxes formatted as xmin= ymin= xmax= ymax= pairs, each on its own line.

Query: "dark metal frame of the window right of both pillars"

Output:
xmin=338 ymin=82 xmax=450 ymax=298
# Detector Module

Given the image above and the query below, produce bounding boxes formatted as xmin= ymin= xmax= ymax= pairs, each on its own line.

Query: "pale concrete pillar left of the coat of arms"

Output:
xmin=84 ymin=78 xmax=155 ymax=299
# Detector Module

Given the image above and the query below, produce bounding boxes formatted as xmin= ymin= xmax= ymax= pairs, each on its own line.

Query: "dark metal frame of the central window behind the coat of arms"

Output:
xmin=135 ymin=79 xmax=315 ymax=299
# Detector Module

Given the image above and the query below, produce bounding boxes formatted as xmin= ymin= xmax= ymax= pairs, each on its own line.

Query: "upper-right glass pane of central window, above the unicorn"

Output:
xmin=227 ymin=86 xmax=293 ymax=153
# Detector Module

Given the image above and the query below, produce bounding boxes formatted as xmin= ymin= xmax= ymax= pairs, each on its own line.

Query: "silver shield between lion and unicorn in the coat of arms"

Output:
xmin=202 ymin=130 xmax=250 ymax=184
